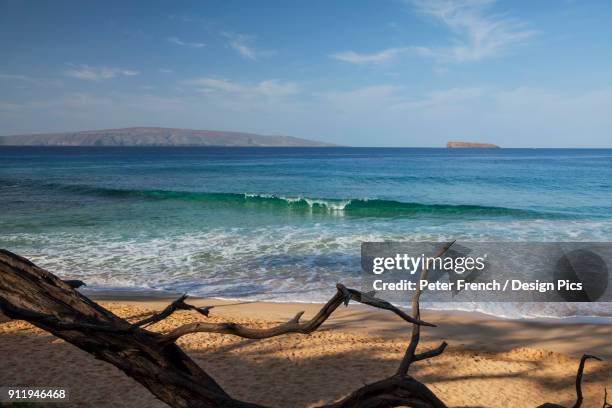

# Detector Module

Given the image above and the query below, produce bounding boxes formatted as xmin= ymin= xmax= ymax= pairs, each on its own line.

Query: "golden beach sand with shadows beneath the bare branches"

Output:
xmin=0 ymin=299 xmax=612 ymax=408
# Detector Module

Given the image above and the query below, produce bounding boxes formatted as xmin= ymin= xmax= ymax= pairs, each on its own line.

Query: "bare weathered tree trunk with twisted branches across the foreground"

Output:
xmin=0 ymin=247 xmax=609 ymax=408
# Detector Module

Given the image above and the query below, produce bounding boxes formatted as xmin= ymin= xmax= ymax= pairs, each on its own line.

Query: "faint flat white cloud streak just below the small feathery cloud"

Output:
xmin=183 ymin=77 xmax=300 ymax=97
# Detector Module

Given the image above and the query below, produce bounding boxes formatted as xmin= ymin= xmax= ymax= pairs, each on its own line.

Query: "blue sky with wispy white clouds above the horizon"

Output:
xmin=0 ymin=0 xmax=612 ymax=147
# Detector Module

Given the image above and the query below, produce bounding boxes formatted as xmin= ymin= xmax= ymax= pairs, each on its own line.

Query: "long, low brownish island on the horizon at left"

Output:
xmin=0 ymin=127 xmax=333 ymax=147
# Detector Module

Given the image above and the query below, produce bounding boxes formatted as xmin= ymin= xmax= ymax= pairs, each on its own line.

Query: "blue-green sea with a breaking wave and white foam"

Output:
xmin=0 ymin=147 xmax=612 ymax=315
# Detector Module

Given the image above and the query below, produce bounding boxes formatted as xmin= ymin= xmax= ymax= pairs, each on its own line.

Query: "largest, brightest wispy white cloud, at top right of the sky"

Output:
xmin=410 ymin=0 xmax=536 ymax=62
